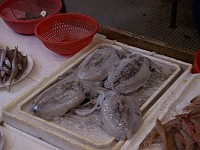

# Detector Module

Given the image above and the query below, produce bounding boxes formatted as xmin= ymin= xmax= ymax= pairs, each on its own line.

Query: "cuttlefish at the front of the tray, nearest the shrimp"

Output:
xmin=101 ymin=92 xmax=143 ymax=141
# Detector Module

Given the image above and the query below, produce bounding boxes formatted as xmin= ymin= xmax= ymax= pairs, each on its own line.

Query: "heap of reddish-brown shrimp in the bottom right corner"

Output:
xmin=141 ymin=96 xmax=200 ymax=150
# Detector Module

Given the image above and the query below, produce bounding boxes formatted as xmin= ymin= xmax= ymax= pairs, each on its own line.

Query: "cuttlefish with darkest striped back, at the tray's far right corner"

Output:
xmin=105 ymin=53 xmax=152 ymax=93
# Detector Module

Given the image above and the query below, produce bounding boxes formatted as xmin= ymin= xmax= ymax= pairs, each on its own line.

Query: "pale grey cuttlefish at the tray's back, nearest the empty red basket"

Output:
xmin=78 ymin=47 xmax=120 ymax=82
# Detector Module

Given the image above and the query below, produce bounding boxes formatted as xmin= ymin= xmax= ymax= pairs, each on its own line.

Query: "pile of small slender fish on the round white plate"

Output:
xmin=0 ymin=47 xmax=28 ymax=90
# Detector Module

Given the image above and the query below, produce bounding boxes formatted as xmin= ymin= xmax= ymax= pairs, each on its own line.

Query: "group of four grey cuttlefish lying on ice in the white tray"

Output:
xmin=31 ymin=47 xmax=155 ymax=141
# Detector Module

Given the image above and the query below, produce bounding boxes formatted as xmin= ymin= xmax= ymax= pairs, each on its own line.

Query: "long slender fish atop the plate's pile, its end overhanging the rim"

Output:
xmin=7 ymin=47 xmax=19 ymax=91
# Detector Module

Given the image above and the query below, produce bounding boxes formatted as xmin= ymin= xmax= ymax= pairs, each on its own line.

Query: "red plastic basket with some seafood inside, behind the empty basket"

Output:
xmin=0 ymin=0 xmax=62 ymax=34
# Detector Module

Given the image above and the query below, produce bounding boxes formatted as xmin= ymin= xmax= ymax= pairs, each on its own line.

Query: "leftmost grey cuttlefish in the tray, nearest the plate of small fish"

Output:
xmin=31 ymin=78 xmax=85 ymax=120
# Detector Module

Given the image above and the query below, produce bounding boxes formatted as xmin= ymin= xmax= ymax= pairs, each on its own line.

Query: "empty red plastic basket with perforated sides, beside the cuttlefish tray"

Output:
xmin=35 ymin=13 xmax=98 ymax=55
